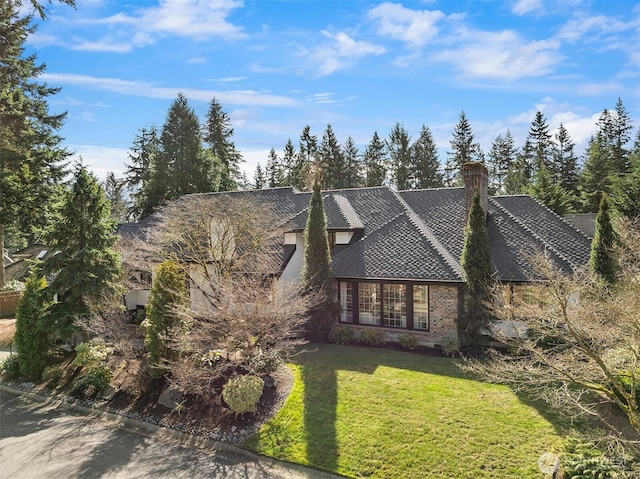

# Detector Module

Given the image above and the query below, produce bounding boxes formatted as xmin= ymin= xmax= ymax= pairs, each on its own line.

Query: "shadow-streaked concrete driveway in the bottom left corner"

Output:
xmin=0 ymin=387 xmax=335 ymax=479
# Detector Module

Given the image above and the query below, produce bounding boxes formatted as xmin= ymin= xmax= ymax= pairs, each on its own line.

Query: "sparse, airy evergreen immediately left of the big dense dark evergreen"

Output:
xmin=125 ymin=126 xmax=160 ymax=220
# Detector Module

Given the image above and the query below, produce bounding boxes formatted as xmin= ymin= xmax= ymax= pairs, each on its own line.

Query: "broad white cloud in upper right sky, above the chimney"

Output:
xmin=432 ymin=30 xmax=564 ymax=81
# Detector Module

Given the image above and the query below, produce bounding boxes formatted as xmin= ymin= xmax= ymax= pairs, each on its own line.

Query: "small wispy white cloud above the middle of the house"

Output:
xmin=311 ymin=30 xmax=386 ymax=75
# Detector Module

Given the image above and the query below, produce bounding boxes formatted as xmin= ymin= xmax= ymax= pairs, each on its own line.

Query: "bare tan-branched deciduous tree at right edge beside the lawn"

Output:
xmin=465 ymin=219 xmax=640 ymax=447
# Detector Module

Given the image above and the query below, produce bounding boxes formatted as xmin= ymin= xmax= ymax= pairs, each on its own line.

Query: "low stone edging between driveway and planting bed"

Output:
xmin=0 ymin=382 xmax=344 ymax=479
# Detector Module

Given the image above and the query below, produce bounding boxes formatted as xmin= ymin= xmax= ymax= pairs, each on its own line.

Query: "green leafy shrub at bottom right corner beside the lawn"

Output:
xmin=562 ymin=439 xmax=624 ymax=479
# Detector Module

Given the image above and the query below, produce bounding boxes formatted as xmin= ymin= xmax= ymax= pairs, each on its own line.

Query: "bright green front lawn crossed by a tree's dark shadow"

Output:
xmin=244 ymin=344 xmax=563 ymax=479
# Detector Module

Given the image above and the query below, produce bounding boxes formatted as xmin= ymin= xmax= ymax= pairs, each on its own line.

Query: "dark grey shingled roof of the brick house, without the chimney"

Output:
xmin=122 ymin=172 xmax=590 ymax=282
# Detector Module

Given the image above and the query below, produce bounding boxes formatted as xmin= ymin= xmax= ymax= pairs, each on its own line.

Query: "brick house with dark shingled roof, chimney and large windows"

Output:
xmin=120 ymin=163 xmax=591 ymax=345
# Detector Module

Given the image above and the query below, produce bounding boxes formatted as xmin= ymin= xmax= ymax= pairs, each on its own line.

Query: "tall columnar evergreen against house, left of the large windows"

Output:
xmin=302 ymin=180 xmax=336 ymax=341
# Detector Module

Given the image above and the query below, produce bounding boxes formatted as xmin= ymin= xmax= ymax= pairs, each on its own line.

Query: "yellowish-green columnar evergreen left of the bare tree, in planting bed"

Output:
xmin=141 ymin=261 xmax=187 ymax=375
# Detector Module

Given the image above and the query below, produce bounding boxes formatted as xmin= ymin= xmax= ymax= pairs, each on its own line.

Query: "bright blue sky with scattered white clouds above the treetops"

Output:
xmin=28 ymin=0 xmax=640 ymax=179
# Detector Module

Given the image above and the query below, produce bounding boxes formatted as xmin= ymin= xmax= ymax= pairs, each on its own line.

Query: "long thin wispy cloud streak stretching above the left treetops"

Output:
xmin=40 ymin=73 xmax=298 ymax=107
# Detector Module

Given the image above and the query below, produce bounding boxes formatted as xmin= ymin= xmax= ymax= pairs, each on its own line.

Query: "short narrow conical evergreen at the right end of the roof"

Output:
xmin=589 ymin=194 xmax=618 ymax=284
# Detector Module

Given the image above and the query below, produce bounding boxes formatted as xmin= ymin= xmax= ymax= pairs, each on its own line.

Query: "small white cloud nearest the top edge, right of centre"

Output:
xmin=368 ymin=2 xmax=445 ymax=47
